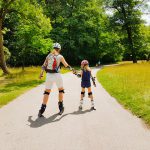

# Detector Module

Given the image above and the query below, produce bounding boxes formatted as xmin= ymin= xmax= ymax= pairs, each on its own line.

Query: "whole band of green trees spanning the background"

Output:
xmin=0 ymin=0 xmax=150 ymax=73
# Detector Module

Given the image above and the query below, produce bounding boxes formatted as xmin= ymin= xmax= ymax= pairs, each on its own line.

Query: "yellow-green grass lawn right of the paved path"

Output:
xmin=97 ymin=62 xmax=150 ymax=125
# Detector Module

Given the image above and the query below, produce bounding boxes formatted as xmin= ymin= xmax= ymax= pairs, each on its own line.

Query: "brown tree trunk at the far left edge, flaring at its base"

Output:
xmin=0 ymin=18 xmax=9 ymax=74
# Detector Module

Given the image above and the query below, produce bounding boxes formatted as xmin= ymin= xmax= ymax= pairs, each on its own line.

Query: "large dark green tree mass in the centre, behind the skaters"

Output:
xmin=39 ymin=0 xmax=124 ymax=64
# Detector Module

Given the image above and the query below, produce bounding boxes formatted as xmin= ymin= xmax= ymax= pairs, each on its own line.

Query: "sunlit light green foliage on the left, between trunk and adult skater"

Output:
xmin=5 ymin=1 xmax=52 ymax=66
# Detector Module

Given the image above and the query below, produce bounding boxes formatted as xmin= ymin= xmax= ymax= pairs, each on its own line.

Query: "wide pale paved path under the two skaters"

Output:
xmin=0 ymin=69 xmax=150 ymax=150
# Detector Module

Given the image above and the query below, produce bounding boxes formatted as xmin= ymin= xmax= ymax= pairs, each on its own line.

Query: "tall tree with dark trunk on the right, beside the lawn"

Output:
xmin=107 ymin=0 xmax=146 ymax=63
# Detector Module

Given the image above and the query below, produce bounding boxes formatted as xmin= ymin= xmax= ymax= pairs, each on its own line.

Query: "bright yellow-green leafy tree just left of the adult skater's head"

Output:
xmin=12 ymin=3 xmax=52 ymax=68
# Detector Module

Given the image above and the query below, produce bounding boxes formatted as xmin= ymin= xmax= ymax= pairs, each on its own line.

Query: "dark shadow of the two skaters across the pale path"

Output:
xmin=28 ymin=109 xmax=92 ymax=128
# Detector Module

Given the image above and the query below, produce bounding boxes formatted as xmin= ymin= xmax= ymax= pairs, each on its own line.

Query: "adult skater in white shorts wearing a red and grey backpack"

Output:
xmin=38 ymin=43 xmax=72 ymax=117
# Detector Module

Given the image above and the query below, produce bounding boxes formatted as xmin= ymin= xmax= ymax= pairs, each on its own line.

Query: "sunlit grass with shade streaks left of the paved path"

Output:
xmin=0 ymin=67 xmax=68 ymax=107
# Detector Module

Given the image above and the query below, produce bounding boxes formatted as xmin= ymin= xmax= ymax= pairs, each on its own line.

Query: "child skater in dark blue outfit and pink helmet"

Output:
xmin=75 ymin=60 xmax=96 ymax=110
